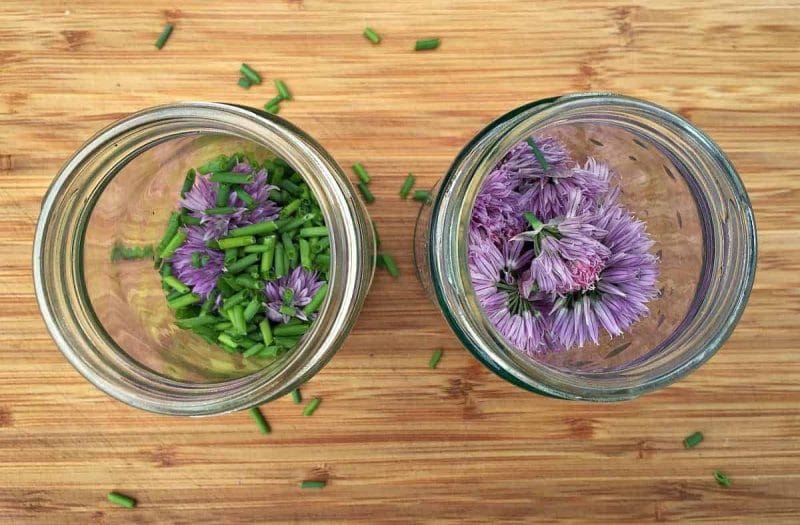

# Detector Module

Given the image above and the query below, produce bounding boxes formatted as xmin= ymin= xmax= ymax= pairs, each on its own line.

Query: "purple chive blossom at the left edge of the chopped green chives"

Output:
xmin=170 ymin=226 xmax=225 ymax=298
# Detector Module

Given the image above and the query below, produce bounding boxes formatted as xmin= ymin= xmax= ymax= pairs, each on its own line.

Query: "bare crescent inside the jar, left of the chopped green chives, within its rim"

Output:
xmin=83 ymin=132 xmax=290 ymax=383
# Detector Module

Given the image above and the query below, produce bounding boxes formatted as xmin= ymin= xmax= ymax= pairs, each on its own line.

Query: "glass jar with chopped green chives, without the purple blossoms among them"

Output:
xmin=34 ymin=102 xmax=375 ymax=415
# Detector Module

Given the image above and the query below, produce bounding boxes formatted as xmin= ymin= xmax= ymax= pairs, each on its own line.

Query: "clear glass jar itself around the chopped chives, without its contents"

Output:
xmin=33 ymin=102 xmax=375 ymax=415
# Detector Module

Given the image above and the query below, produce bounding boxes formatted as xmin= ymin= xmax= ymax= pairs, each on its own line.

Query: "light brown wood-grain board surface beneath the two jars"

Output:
xmin=0 ymin=0 xmax=800 ymax=524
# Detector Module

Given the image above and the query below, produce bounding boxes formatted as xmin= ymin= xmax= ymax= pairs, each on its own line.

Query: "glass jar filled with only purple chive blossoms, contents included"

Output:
xmin=414 ymin=93 xmax=756 ymax=401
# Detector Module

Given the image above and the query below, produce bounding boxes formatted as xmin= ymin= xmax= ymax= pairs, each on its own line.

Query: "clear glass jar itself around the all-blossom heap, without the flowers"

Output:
xmin=415 ymin=93 xmax=756 ymax=401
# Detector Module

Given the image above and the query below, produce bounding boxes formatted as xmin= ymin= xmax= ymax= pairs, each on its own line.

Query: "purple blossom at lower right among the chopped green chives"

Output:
xmin=264 ymin=266 xmax=323 ymax=323
